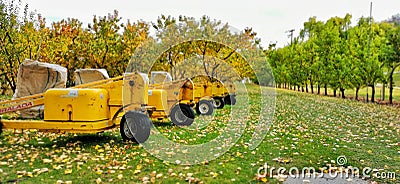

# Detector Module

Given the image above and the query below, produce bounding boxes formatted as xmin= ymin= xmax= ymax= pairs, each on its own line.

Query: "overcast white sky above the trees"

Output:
xmin=23 ymin=0 xmax=400 ymax=47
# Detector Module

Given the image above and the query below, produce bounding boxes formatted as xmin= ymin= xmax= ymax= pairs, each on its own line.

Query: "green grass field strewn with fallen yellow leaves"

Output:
xmin=0 ymin=86 xmax=400 ymax=183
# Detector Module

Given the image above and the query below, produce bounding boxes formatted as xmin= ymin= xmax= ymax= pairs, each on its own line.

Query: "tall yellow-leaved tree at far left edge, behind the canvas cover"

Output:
xmin=0 ymin=1 xmax=44 ymax=93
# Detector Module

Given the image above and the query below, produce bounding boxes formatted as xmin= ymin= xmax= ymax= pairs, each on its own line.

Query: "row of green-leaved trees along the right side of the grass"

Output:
xmin=265 ymin=14 xmax=400 ymax=103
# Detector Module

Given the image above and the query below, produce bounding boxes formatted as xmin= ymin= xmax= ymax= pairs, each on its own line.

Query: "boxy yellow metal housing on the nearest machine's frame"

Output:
xmin=44 ymin=89 xmax=110 ymax=121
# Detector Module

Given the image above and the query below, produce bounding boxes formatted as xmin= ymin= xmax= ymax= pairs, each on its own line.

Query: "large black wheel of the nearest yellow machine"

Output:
xmin=119 ymin=111 xmax=151 ymax=143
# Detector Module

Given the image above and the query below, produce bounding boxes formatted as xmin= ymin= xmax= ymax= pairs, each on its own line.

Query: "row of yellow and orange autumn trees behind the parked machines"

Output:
xmin=0 ymin=0 xmax=262 ymax=94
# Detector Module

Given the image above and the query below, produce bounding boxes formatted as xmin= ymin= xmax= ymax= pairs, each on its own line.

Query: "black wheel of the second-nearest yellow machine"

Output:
xmin=169 ymin=104 xmax=195 ymax=126
